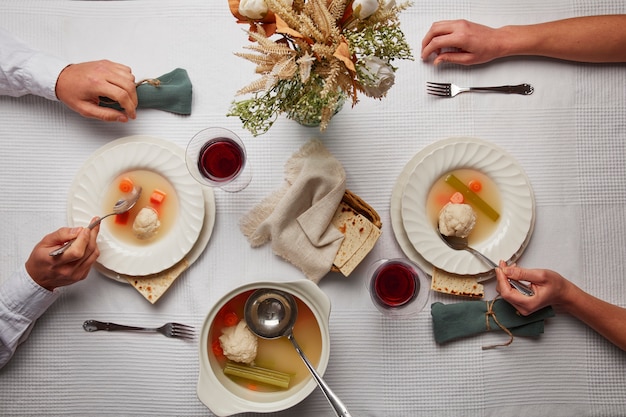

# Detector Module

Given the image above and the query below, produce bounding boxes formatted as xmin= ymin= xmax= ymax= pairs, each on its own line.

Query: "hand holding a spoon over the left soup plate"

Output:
xmin=26 ymin=219 xmax=100 ymax=291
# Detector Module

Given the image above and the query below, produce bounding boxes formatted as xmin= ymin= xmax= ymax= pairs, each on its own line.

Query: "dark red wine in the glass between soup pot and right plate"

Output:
xmin=371 ymin=262 xmax=419 ymax=307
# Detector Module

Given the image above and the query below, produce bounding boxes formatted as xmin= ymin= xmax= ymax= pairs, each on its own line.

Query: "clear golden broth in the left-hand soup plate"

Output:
xmin=103 ymin=170 xmax=178 ymax=245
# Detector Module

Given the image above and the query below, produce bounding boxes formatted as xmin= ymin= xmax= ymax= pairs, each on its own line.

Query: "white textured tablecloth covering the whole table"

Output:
xmin=0 ymin=0 xmax=626 ymax=417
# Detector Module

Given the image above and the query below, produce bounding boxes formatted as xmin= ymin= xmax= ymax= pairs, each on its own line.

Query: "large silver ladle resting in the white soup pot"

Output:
xmin=244 ymin=289 xmax=351 ymax=417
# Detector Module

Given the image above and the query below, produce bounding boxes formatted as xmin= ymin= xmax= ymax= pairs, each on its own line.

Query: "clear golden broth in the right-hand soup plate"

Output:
xmin=426 ymin=168 xmax=502 ymax=246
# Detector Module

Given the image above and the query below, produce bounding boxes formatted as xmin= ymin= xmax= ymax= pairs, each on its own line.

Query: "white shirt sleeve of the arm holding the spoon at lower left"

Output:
xmin=0 ymin=266 xmax=59 ymax=368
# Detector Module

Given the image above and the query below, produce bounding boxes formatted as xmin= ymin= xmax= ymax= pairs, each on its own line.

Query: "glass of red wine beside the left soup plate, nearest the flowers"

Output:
xmin=185 ymin=127 xmax=252 ymax=193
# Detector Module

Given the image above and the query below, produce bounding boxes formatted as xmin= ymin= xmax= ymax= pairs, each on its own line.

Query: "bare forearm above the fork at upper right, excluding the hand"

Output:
xmin=497 ymin=15 xmax=626 ymax=62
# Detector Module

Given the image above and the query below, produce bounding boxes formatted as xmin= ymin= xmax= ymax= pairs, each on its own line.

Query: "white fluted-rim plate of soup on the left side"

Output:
xmin=68 ymin=136 xmax=205 ymax=276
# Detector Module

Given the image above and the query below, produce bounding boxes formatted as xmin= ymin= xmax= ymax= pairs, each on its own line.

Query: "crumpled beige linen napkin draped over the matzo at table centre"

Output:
xmin=240 ymin=139 xmax=346 ymax=283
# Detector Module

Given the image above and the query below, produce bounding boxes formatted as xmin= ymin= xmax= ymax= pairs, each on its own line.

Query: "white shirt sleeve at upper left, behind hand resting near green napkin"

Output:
xmin=0 ymin=28 xmax=70 ymax=100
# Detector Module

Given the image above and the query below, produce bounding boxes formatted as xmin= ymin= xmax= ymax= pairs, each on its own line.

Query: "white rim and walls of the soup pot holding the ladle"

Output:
xmin=197 ymin=279 xmax=330 ymax=416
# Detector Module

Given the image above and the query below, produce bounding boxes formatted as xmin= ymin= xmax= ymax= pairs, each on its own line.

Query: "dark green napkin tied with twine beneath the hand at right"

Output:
xmin=431 ymin=298 xmax=555 ymax=343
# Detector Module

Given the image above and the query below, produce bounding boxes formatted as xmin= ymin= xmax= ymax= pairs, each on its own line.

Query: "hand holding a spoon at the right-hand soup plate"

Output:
xmin=496 ymin=261 xmax=571 ymax=316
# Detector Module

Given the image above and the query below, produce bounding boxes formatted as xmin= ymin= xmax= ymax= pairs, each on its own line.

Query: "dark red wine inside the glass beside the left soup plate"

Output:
xmin=198 ymin=138 xmax=245 ymax=182
